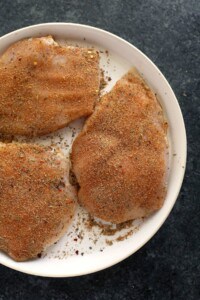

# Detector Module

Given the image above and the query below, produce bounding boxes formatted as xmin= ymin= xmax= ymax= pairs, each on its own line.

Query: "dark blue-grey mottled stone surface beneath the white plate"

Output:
xmin=0 ymin=0 xmax=200 ymax=300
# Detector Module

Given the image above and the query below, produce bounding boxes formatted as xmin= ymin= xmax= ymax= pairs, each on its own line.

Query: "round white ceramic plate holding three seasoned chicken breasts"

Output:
xmin=0 ymin=23 xmax=186 ymax=277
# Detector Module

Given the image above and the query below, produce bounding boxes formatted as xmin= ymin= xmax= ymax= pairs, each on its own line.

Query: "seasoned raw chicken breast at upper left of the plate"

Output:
xmin=0 ymin=36 xmax=100 ymax=136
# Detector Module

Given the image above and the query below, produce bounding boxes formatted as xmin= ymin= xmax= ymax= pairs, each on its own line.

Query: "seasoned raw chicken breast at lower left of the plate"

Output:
xmin=0 ymin=144 xmax=75 ymax=261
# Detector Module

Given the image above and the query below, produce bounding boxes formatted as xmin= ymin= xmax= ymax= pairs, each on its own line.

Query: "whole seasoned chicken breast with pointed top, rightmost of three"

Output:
xmin=72 ymin=69 xmax=167 ymax=223
